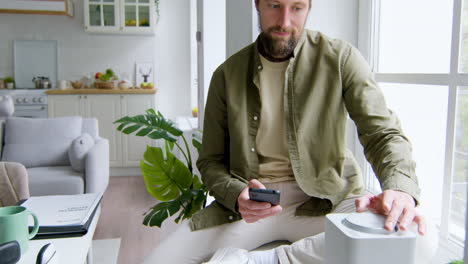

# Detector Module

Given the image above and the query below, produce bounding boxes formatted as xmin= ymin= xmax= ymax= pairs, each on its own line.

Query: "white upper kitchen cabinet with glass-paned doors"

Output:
xmin=84 ymin=0 xmax=156 ymax=34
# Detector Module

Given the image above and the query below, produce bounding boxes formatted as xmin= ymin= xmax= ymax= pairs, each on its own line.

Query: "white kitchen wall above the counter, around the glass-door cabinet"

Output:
xmin=0 ymin=0 xmax=190 ymax=116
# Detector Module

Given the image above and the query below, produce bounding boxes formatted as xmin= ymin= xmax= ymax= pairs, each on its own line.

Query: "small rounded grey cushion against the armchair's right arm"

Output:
xmin=68 ymin=133 xmax=94 ymax=172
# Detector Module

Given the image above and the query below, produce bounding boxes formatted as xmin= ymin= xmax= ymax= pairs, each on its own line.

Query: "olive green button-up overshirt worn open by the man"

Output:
xmin=191 ymin=30 xmax=420 ymax=230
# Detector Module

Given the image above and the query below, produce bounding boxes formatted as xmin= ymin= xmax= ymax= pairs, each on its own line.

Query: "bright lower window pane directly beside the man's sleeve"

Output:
xmin=380 ymin=83 xmax=448 ymax=223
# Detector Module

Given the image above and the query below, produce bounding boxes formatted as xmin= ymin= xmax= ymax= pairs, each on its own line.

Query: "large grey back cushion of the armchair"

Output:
xmin=2 ymin=117 xmax=82 ymax=168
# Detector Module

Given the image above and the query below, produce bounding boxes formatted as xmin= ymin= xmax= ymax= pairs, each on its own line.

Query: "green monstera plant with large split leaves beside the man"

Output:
xmin=114 ymin=109 xmax=207 ymax=227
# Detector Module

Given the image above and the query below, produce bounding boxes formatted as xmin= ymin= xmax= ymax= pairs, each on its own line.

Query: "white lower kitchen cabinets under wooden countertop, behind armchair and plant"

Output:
xmin=48 ymin=94 xmax=155 ymax=167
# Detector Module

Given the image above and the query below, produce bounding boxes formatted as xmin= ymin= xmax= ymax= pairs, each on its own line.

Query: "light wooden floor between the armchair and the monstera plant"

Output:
xmin=94 ymin=176 xmax=161 ymax=264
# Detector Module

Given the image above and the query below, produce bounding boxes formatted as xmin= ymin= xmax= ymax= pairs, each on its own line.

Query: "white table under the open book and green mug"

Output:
xmin=18 ymin=206 xmax=101 ymax=264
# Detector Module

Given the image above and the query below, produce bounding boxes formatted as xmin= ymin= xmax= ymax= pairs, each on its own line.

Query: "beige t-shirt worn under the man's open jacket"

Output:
xmin=256 ymin=56 xmax=294 ymax=183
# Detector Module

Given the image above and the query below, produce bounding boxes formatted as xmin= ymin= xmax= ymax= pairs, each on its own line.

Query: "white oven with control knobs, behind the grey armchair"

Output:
xmin=0 ymin=89 xmax=48 ymax=118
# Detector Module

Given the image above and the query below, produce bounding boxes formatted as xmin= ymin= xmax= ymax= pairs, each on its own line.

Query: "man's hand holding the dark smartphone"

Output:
xmin=237 ymin=179 xmax=283 ymax=223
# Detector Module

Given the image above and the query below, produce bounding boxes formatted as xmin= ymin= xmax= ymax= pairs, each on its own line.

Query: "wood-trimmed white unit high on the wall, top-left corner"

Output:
xmin=0 ymin=0 xmax=74 ymax=17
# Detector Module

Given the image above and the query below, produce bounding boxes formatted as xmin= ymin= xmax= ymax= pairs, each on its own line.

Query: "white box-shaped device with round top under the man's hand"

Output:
xmin=325 ymin=212 xmax=416 ymax=264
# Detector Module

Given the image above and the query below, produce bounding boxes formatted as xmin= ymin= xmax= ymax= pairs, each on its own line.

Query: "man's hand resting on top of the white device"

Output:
xmin=356 ymin=190 xmax=426 ymax=235
